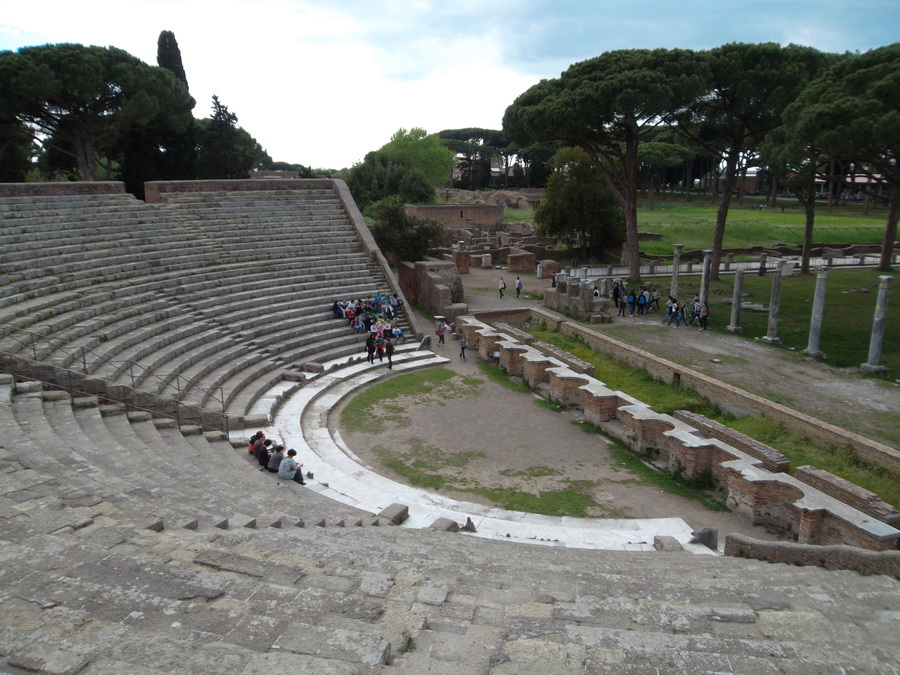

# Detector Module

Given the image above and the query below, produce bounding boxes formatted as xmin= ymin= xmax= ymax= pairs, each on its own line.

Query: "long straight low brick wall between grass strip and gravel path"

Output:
xmin=531 ymin=308 xmax=900 ymax=476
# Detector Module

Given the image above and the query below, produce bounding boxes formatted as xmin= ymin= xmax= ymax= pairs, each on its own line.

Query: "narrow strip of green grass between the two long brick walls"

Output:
xmin=528 ymin=326 xmax=900 ymax=506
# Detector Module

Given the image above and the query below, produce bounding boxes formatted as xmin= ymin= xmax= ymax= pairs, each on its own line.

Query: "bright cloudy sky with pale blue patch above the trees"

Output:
xmin=0 ymin=0 xmax=900 ymax=169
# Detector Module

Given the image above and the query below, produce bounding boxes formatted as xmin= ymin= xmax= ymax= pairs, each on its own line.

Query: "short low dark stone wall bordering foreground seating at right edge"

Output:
xmin=725 ymin=534 xmax=900 ymax=579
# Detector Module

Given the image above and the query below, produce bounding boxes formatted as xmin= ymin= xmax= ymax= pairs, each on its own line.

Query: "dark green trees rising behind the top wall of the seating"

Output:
xmin=0 ymin=31 xmax=298 ymax=198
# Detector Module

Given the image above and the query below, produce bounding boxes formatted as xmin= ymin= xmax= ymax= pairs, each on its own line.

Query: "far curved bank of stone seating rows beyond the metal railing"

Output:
xmin=0 ymin=189 xmax=409 ymax=426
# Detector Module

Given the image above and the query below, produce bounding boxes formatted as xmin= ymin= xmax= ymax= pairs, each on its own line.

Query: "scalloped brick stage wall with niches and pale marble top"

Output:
xmin=456 ymin=315 xmax=900 ymax=550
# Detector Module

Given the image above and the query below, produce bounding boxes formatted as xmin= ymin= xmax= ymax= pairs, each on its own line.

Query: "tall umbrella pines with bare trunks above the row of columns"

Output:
xmin=503 ymin=43 xmax=900 ymax=279
